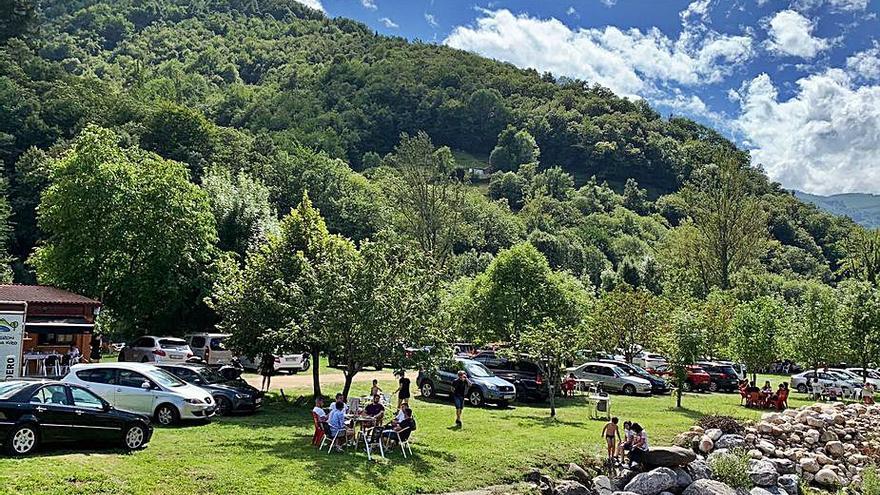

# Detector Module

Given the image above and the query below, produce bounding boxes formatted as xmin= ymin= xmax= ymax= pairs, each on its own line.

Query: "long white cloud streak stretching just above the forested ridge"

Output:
xmin=444 ymin=9 xmax=753 ymax=96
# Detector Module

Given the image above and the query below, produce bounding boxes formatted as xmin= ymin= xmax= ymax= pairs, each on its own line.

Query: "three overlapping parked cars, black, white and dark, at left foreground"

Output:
xmin=0 ymin=362 xmax=263 ymax=455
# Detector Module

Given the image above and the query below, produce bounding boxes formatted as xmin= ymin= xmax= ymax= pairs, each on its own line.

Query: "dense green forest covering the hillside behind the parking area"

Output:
xmin=0 ymin=0 xmax=880 ymax=402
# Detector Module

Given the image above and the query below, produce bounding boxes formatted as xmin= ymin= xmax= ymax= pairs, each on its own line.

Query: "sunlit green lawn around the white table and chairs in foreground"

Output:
xmin=0 ymin=378 xmax=805 ymax=495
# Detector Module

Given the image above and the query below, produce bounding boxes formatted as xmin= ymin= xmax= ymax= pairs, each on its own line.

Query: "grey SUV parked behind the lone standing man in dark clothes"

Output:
xmin=416 ymin=358 xmax=516 ymax=407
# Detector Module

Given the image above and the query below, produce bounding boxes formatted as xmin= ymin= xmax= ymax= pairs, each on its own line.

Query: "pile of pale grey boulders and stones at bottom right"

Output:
xmin=526 ymin=403 xmax=880 ymax=495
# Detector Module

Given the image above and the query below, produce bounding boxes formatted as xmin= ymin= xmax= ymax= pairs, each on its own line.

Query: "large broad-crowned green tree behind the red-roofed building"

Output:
xmin=31 ymin=126 xmax=217 ymax=334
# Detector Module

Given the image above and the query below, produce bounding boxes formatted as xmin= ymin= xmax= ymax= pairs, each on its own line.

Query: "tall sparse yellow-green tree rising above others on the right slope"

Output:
xmin=681 ymin=152 xmax=768 ymax=292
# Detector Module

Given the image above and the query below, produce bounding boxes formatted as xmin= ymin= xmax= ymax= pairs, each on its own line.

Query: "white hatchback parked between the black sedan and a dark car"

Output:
xmin=62 ymin=363 xmax=216 ymax=426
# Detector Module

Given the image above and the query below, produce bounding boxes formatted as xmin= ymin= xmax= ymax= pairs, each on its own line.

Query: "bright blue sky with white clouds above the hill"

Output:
xmin=301 ymin=0 xmax=880 ymax=198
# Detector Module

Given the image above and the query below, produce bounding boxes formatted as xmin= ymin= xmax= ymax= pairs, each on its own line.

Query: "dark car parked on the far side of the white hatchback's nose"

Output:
xmin=157 ymin=364 xmax=263 ymax=416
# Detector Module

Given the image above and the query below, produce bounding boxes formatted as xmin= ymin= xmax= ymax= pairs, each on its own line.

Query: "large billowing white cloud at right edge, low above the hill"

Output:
xmin=736 ymin=69 xmax=880 ymax=194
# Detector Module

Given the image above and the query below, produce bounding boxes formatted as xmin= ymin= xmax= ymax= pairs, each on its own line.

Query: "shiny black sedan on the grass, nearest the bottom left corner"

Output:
xmin=0 ymin=380 xmax=153 ymax=455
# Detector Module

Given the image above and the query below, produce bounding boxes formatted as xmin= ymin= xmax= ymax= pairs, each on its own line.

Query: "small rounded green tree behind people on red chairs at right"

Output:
xmin=730 ymin=296 xmax=791 ymax=381
